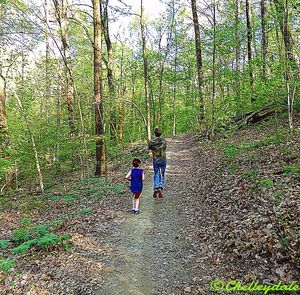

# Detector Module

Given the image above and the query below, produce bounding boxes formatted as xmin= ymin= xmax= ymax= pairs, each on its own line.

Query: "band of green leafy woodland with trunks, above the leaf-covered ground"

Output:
xmin=0 ymin=0 xmax=300 ymax=193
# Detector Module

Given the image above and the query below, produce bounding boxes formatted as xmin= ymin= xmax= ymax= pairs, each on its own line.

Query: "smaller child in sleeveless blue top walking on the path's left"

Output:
xmin=126 ymin=159 xmax=145 ymax=214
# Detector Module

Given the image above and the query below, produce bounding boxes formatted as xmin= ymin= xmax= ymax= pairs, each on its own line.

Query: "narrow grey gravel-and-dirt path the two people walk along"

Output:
xmin=99 ymin=137 xmax=197 ymax=294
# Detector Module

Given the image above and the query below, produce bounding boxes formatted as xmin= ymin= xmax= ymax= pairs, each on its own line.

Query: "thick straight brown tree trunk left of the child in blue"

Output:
xmin=92 ymin=0 xmax=106 ymax=175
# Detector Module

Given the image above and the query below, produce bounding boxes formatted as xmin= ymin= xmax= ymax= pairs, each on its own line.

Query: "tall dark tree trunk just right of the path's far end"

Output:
xmin=191 ymin=0 xmax=205 ymax=125
